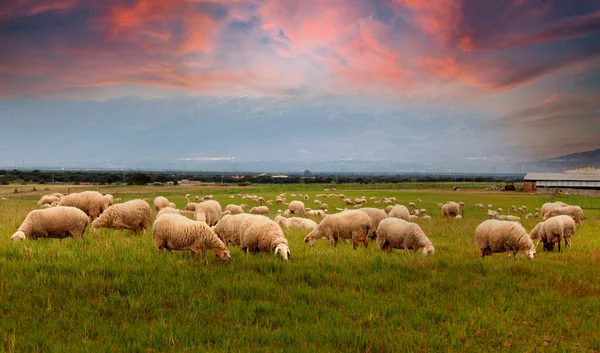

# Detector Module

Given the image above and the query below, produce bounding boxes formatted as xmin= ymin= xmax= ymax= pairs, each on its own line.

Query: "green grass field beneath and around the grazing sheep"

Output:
xmin=0 ymin=183 xmax=600 ymax=352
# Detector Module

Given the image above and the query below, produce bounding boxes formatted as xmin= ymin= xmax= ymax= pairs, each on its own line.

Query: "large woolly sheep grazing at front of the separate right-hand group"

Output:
xmin=475 ymin=219 xmax=535 ymax=259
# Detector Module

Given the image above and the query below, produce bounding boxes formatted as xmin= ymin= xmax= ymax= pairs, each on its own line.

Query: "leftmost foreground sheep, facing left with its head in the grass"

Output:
xmin=10 ymin=206 xmax=89 ymax=242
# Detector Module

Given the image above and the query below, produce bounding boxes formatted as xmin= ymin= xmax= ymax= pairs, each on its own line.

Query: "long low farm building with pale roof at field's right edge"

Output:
xmin=523 ymin=167 xmax=600 ymax=196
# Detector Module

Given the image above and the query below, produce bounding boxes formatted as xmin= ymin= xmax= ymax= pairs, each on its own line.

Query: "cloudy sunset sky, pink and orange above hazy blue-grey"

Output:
xmin=0 ymin=0 xmax=600 ymax=171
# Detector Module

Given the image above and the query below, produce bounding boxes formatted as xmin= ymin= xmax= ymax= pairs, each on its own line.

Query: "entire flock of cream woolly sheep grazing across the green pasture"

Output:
xmin=11 ymin=191 xmax=583 ymax=261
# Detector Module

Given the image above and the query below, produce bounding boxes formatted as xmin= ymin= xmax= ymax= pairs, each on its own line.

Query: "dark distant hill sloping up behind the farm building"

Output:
xmin=521 ymin=148 xmax=600 ymax=173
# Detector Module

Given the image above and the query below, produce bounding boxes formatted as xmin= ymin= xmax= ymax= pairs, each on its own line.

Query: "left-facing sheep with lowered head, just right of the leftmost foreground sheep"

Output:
xmin=92 ymin=200 xmax=152 ymax=232
